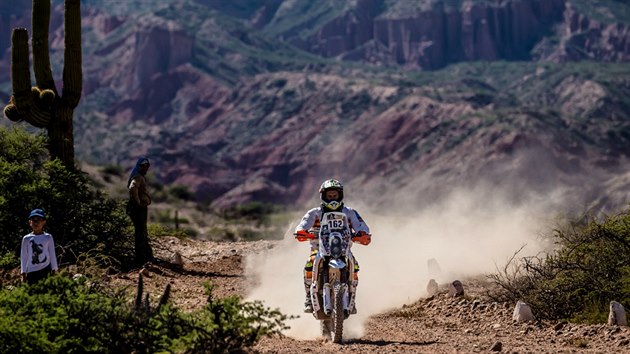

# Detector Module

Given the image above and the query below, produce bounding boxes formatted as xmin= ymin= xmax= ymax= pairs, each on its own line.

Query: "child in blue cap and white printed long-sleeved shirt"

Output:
xmin=20 ymin=209 xmax=58 ymax=284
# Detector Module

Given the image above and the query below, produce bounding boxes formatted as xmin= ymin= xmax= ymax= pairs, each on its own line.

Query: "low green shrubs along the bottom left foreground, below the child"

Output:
xmin=0 ymin=275 xmax=287 ymax=353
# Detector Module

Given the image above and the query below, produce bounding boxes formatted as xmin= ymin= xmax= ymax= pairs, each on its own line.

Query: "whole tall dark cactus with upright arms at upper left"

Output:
xmin=4 ymin=0 xmax=83 ymax=168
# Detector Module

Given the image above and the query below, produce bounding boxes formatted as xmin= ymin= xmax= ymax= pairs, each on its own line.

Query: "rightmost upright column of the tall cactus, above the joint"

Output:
xmin=62 ymin=0 xmax=83 ymax=109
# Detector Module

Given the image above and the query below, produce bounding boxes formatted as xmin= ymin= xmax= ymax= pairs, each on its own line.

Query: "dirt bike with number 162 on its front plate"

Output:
xmin=296 ymin=212 xmax=370 ymax=343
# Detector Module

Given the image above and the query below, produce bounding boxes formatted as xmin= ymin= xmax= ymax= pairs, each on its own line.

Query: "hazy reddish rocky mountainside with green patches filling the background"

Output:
xmin=0 ymin=0 xmax=630 ymax=207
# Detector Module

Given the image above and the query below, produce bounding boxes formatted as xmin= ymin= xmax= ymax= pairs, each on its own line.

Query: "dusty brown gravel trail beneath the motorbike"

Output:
xmin=111 ymin=238 xmax=630 ymax=353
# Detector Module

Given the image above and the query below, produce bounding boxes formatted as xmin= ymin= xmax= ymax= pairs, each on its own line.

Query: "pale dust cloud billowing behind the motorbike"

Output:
xmin=246 ymin=187 xmax=564 ymax=339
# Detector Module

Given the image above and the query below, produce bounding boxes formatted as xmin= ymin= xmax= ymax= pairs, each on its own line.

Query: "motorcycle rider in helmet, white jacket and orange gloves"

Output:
xmin=294 ymin=179 xmax=372 ymax=313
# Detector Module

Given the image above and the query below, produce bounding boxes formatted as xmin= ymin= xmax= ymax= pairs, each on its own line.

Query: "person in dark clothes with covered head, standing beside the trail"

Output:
xmin=127 ymin=157 xmax=153 ymax=264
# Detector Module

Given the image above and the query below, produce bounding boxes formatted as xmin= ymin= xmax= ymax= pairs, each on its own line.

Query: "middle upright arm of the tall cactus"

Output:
xmin=32 ymin=0 xmax=58 ymax=96
